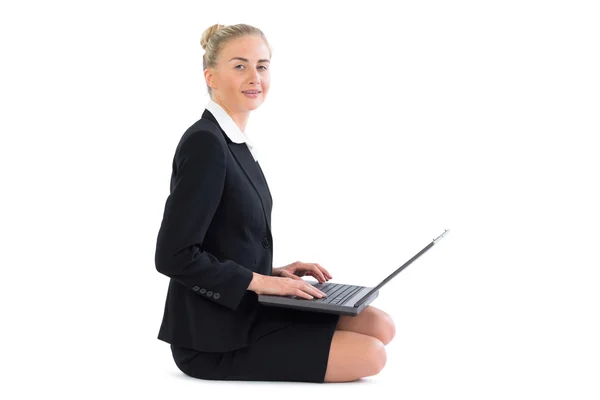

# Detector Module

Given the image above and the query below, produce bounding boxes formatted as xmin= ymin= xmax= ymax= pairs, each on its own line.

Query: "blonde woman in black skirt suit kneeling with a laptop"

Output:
xmin=155 ymin=24 xmax=394 ymax=382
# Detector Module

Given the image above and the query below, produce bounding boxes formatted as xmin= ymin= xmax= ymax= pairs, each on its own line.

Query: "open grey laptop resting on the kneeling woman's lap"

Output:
xmin=258 ymin=229 xmax=450 ymax=316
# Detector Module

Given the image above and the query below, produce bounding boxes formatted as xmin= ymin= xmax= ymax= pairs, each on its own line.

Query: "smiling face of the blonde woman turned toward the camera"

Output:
xmin=204 ymin=36 xmax=271 ymax=113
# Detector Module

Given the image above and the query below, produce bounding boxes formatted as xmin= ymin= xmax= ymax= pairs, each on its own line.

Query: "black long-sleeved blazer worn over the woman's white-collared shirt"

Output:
xmin=155 ymin=110 xmax=286 ymax=352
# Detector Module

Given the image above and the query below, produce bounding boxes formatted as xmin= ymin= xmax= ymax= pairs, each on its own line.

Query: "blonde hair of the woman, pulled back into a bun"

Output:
xmin=200 ymin=24 xmax=273 ymax=97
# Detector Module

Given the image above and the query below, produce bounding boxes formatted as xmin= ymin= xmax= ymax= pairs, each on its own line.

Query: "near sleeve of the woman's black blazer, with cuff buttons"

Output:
xmin=155 ymin=131 xmax=253 ymax=310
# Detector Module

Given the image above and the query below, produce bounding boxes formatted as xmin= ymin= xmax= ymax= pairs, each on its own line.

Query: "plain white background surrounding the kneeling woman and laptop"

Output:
xmin=0 ymin=0 xmax=600 ymax=399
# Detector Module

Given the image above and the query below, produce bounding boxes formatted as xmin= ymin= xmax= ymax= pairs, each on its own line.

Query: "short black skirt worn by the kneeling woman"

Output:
xmin=171 ymin=306 xmax=340 ymax=383
